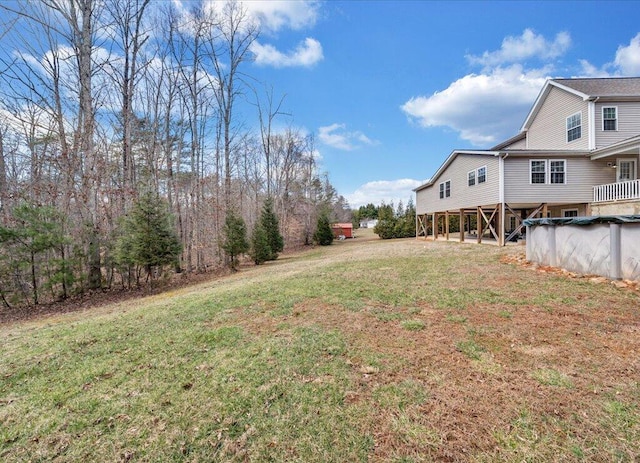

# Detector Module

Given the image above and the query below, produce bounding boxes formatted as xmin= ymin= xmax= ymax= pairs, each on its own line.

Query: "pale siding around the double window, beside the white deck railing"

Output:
xmin=504 ymin=156 xmax=615 ymax=204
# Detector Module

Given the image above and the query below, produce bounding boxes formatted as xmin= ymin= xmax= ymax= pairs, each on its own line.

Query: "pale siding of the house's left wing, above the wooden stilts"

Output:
xmin=416 ymin=154 xmax=500 ymax=214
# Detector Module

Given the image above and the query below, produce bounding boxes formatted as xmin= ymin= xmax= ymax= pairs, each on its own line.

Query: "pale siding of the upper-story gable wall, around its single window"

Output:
xmin=527 ymin=87 xmax=589 ymax=150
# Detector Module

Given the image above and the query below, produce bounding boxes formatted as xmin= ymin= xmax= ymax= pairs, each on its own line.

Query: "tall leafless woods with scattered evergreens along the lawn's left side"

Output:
xmin=0 ymin=0 xmax=350 ymax=306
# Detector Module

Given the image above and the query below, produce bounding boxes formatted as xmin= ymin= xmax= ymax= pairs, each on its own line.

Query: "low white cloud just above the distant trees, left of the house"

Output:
xmin=345 ymin=178 xmax=423 ymax=209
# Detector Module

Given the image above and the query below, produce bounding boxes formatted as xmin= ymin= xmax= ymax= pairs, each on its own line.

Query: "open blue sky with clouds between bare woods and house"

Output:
xmin=241 ymin=1 xmax=640 ymax=207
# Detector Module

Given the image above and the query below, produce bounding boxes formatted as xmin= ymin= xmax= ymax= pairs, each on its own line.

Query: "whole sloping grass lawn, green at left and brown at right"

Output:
xmin=0 ymin=233 xmax=640 ymax=462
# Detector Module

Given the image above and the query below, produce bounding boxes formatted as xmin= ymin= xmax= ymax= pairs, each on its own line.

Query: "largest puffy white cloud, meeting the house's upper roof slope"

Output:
xmin=401 ymin=64 xmax=547 ymax=146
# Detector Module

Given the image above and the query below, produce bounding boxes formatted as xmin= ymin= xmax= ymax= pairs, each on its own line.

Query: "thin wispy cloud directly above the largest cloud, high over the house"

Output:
xmin=467 ymin=29 xmax=571 ymax=67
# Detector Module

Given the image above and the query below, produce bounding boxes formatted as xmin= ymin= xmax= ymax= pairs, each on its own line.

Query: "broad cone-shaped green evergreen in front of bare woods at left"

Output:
xmin=115 ymin=193 xmax=181 ymax=283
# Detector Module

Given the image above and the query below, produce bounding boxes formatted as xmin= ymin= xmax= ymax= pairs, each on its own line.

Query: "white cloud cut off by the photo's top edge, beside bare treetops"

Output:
xmin=243 ymin=0 xmax=320 ymax=32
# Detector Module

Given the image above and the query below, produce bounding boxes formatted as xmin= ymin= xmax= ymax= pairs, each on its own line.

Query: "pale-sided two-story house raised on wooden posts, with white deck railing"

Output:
xmin=414 ymin=77 xmax=640 ymax=244
